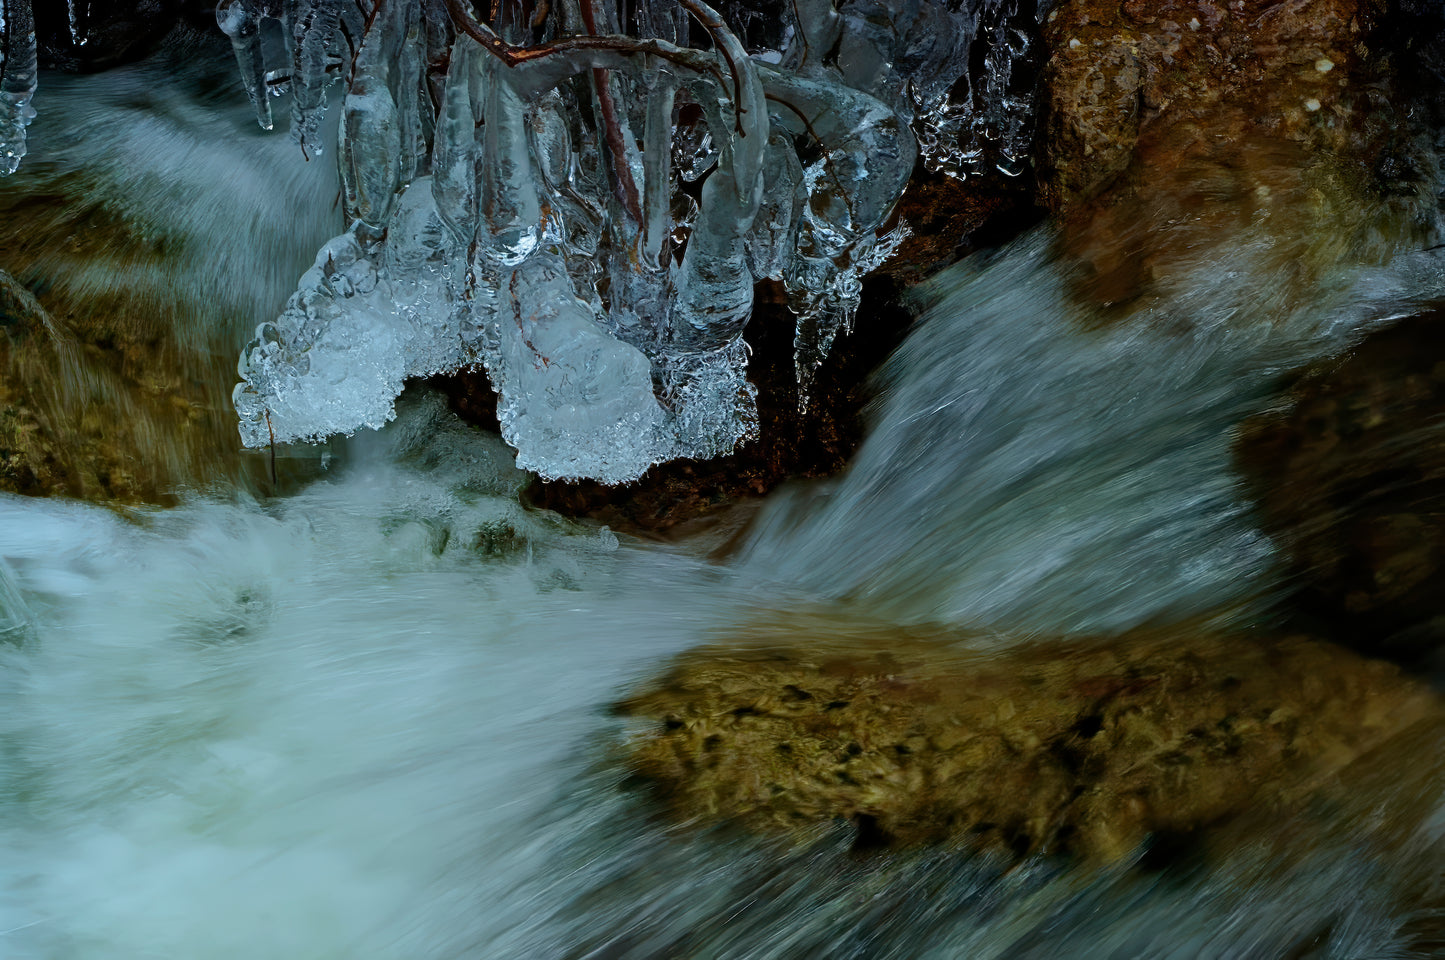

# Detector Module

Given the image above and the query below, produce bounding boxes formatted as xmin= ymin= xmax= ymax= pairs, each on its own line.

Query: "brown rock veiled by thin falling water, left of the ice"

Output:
xmin=0 ymin=39 xmax=337 ymax=503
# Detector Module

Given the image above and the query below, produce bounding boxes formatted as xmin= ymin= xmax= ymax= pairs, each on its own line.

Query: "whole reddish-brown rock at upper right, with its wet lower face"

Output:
xmin=1039 ymin=0 xmax=1438 ymax=304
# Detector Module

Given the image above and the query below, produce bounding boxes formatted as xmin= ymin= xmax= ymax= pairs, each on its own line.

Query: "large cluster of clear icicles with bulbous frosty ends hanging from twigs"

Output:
xmin=217 ymin=0 xmax=1040 ymax=483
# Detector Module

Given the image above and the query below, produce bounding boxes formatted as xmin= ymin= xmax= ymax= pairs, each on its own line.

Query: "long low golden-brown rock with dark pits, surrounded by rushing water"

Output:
xmin=620 ymin=629 xmax=1441 ymax=860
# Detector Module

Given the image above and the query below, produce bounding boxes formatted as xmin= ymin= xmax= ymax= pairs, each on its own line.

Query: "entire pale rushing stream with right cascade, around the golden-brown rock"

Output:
xmin=0 ymin=37 xmax=1445 ymax=960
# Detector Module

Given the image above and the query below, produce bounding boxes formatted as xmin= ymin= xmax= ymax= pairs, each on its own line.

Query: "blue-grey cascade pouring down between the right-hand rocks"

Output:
xmin=750 ymin=234 xmax=1445 ymax=633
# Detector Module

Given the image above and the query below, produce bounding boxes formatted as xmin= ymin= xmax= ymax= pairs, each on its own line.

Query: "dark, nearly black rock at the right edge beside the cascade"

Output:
xmin=1237 ymin=312 xmax=1445 ymax=659
